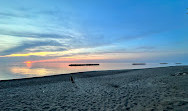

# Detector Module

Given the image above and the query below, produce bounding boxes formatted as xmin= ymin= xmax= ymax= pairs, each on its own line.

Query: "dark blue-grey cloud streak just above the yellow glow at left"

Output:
xmin=1 ymin=40 xmax=66 ymax=55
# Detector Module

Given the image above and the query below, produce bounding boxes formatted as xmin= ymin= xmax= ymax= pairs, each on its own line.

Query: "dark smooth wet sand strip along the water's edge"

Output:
xmin=0 ymin=65 xmax=188 ymax=89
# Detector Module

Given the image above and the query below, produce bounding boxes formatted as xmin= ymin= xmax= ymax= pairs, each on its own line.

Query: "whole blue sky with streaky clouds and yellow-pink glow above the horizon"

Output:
xmin=0 ymin=0 xmax=188 ymax=63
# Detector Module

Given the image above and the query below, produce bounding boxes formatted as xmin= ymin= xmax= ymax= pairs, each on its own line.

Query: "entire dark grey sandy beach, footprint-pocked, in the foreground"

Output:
xmin=0 ymin=66 xmax=188 ymax=111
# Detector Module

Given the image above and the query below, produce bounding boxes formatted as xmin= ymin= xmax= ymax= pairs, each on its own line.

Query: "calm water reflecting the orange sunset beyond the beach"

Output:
xmin=0 ymin=63 xmax=185 ymax=80
